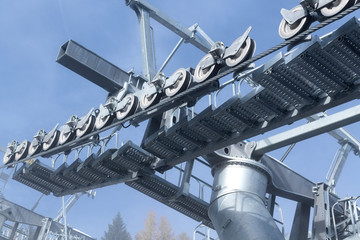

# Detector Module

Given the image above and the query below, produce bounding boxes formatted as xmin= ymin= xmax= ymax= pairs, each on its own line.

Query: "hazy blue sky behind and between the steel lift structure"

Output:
xmin=0 ymin=0 xmax=360 ymax=238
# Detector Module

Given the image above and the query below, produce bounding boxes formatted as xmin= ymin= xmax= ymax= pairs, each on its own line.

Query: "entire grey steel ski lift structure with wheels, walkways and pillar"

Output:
xmin=4 ymin=0 xmax=360 ymax=240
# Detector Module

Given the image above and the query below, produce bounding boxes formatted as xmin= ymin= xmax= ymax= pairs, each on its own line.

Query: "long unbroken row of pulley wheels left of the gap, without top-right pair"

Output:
xmin=3 ymin=28 xmax=255 ymax=165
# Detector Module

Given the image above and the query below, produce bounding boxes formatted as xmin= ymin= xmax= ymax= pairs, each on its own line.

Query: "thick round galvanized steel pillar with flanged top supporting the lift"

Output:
xmin=208 ymin=158 xmax=284 ymax=240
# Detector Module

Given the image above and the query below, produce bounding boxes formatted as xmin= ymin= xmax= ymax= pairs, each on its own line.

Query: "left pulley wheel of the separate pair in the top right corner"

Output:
xmin=279 ymin=6 xmax=311 ymax=39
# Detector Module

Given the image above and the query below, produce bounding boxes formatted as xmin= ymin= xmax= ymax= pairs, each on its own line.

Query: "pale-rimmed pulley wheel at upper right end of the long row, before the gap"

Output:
xmin=225 ymin=37 xmax=256 ymax=67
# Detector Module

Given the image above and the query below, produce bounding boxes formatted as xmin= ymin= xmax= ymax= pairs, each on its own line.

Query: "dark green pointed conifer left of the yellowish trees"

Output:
xmin=101 ymin=213 xmax=131 ymax=240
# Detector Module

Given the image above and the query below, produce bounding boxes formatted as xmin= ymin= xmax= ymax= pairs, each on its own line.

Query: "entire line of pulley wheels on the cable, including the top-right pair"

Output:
xmin=3 ymin=0 xmax=355 ymax=165
